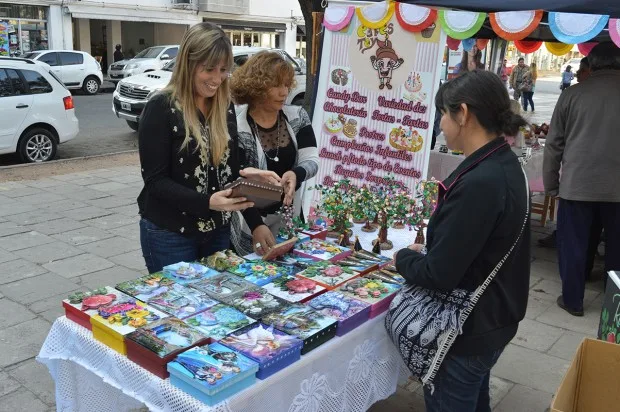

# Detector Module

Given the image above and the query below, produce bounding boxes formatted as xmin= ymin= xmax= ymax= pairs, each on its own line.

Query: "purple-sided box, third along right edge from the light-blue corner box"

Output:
xmin=307 ymin=291 xmax=370 ymax=336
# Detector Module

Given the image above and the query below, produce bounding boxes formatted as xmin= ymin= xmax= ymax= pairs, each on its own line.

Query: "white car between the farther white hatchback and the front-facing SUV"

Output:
xmin=108 ymin=45 xmax=179 ymax=82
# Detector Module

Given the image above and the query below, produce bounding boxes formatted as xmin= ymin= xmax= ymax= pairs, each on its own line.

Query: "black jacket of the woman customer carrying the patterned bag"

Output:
xmin=396 ymin=138 xmax=530 ymax=355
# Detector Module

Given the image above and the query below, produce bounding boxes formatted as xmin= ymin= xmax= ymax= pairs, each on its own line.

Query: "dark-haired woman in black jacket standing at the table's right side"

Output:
xmin=395 ymin=71 xmax=530 ymax=412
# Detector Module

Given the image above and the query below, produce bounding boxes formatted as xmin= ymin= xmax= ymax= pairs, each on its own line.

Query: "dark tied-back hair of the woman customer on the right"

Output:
xmin=435 ymin=70 xmax=527 ymax=136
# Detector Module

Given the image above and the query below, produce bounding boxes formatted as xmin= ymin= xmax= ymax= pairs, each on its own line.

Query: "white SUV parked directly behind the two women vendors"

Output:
xmin=112 ymin=46 xmax=306 ymax=131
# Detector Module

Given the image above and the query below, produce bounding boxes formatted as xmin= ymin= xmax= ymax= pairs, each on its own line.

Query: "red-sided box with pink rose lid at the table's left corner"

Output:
xmin=62 ymin=286 xmax=125 ymax=330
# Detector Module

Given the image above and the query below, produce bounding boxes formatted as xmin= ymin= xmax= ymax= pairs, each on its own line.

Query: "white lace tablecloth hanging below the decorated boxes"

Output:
xmin=37 ymin=316 xmax=406 ymax=412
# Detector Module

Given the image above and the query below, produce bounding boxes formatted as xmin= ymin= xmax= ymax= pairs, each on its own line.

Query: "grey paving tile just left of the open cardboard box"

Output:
xmin=491 ymin=344 xmax=570 ymax=393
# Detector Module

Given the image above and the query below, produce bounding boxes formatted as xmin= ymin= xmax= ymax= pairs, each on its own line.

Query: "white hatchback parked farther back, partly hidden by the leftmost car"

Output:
xmin=22 ymin=50 xmax=103 ymax=94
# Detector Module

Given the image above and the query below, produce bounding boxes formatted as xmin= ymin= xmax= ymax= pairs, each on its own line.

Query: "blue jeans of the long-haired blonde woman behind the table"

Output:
xmin=140 ymin=218 xmax=230 ymax=273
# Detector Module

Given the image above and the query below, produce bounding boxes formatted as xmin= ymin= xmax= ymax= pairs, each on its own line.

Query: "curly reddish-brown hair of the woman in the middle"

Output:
xmin=230 ymin=51 xmax=295 ymax=106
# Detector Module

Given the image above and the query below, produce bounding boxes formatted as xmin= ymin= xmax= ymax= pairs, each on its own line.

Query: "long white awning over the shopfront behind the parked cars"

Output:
xmin=67 ymin=3 xmax=202 ymax=25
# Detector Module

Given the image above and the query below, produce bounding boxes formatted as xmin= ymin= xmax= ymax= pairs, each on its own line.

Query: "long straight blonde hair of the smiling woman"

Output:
xmin=164 ymin=23 xmax=233 ymax=165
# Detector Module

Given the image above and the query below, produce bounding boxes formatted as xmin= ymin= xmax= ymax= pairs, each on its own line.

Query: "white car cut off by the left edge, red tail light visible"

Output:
xmin=0 ymin=57 xmax=79 ymax=163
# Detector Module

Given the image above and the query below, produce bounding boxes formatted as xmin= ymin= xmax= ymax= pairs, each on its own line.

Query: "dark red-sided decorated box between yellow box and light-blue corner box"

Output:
xmin=125 ymin=318 xmax=209 ymax=379
